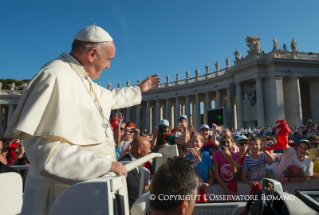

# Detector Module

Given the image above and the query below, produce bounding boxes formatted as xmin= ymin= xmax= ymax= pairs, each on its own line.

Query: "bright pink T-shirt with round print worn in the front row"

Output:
xmin=212 ymin=151 xmax=239 ymax=182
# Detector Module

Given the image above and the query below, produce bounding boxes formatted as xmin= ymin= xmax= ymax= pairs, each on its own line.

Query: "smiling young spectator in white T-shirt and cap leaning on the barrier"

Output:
xmin=274 ymin=139 xmax=313 ymax=184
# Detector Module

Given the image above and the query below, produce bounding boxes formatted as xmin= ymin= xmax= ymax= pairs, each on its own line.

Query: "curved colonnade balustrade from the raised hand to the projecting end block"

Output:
xmin=159 ymin=67 xmax=231 ymax=88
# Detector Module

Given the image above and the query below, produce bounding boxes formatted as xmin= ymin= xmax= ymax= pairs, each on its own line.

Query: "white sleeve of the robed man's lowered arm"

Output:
xmin=23 ymin=134 xmax=112 ymax=184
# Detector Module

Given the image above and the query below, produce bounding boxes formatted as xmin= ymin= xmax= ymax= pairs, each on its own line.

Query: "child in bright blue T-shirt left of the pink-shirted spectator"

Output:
xmin=185 ymin=134 xmax=213 ymax=190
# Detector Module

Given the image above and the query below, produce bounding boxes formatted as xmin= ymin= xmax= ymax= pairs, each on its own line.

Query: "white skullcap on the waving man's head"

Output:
xmin=74 ymin=24 xmax=113 ymax=43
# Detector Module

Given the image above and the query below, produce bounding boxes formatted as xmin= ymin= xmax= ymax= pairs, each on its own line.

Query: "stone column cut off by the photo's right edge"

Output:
xmin=309 ymin=79 xmax=319 ymax=124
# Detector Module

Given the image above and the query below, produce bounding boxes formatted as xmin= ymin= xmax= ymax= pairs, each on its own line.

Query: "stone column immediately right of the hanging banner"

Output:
xmin=256 ymin=78 xmax=266 ymax=128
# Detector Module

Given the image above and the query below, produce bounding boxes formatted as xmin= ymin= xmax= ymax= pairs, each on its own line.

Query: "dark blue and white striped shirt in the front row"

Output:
xmin=242 ymin=153 xmax=267 ymax=181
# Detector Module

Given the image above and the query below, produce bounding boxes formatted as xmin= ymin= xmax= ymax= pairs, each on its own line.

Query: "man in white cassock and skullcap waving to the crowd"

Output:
xmin=5 ymin=25 xmax=160 ymax=214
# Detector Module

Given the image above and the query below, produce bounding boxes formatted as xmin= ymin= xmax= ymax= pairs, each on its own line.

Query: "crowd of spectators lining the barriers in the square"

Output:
xmin=0 ymin=113 xmax=319 ymax=207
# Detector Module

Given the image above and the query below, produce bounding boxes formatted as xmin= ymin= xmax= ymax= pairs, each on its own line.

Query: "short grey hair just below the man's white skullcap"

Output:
xmin=71 ymin=40 xmax=112 ymax=54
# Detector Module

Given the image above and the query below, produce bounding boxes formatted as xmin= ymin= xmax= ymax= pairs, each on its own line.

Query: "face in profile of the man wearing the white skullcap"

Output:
xmin=87 ymin=42 xmax=115 ymax=79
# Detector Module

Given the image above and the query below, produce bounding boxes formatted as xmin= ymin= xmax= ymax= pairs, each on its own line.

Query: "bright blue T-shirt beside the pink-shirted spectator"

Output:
xmin=185 ymin=153 xmax=213 ymax=183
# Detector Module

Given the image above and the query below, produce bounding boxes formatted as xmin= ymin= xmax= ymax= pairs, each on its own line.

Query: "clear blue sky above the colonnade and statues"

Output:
xmin=0 ymin=0 xmax=319 ymax=87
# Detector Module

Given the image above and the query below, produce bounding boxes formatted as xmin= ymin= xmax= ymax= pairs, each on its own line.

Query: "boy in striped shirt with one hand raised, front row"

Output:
xmin=241 ymin=137 xmax=274 ymax=188
